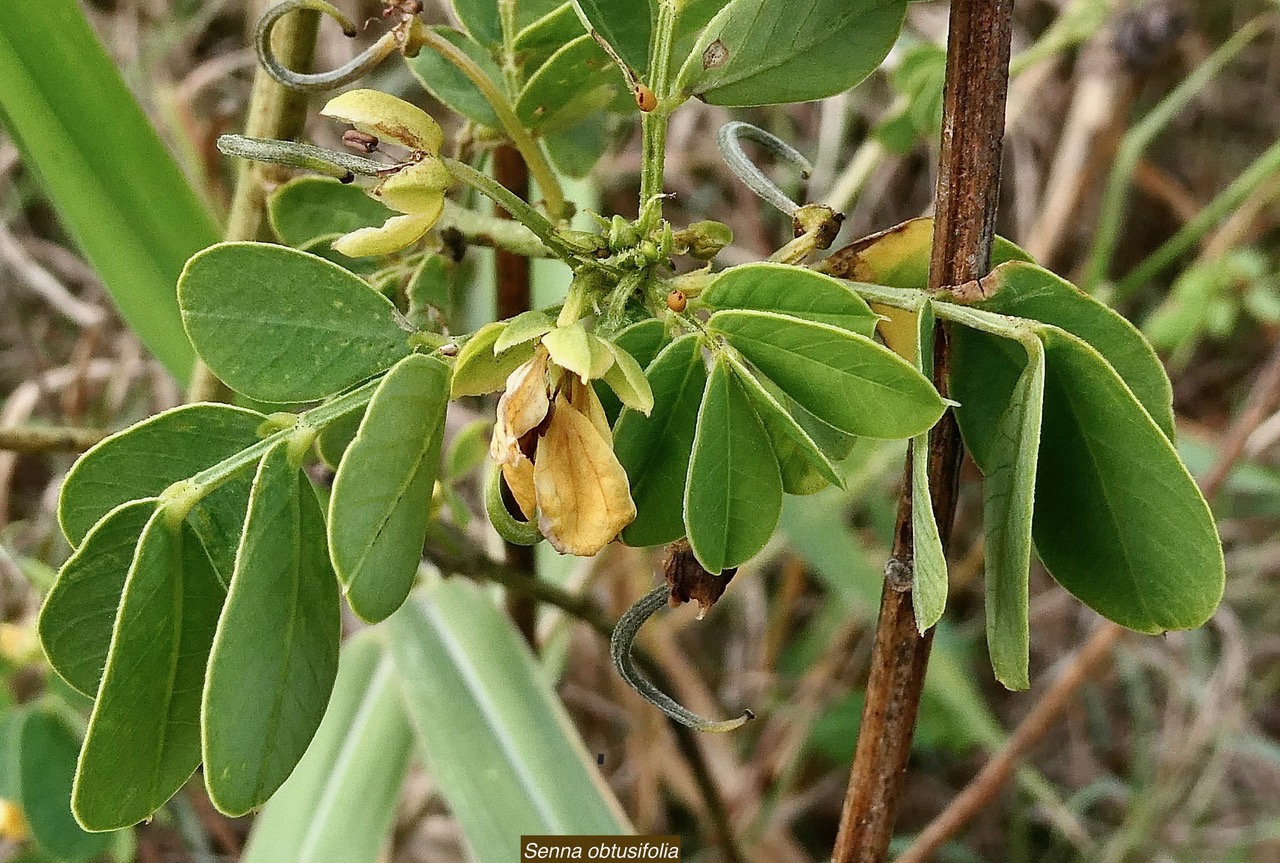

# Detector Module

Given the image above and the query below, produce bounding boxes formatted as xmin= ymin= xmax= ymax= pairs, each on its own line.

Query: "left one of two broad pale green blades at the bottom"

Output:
xmin=241 ymin=630 xmax=413 ymax=863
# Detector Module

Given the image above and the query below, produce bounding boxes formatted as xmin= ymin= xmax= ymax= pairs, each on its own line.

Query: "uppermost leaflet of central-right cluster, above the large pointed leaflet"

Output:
xmin=701 ymin=262 xmax=879 ymax=338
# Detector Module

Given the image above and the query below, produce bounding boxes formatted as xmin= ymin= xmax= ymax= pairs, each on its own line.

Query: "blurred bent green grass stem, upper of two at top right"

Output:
xmin=1080 ymin=18 xmax=1267 ymax=293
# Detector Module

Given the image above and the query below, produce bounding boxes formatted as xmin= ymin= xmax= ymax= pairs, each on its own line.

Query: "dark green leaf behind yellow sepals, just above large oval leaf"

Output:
xmin=266 ymin=177 xmax=396 ymax=248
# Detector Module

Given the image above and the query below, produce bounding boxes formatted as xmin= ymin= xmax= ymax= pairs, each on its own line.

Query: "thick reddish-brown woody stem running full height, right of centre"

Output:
xmin=832 ymin=0 xmax=1012 ymax=863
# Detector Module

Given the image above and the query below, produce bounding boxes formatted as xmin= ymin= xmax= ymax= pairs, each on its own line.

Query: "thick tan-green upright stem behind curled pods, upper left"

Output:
xmin=187 ymin=3 xmax=320 ymax=402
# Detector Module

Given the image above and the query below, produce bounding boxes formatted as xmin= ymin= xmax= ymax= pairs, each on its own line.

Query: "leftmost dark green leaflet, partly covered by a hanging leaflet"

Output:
xmin=37 ymin=498 xmax=156 ymax=698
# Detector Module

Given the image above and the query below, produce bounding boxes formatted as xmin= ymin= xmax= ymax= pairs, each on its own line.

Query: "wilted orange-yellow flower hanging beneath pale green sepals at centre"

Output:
xmin=489 ymin=340 xmax=637 ymax=557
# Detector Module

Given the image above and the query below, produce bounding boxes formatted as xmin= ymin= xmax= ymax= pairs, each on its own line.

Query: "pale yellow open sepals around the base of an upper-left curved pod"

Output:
xmin=320 ymin=90 xmax=453 ymax=257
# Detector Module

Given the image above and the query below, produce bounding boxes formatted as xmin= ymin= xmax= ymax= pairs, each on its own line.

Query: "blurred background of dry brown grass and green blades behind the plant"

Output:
xmin=0 ymin=0 xmax=1280 ymax=863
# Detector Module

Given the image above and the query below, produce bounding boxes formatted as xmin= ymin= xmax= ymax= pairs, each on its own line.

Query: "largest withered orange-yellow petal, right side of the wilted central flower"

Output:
xmin=534 ymin=394 xmax=636 ymax=557
